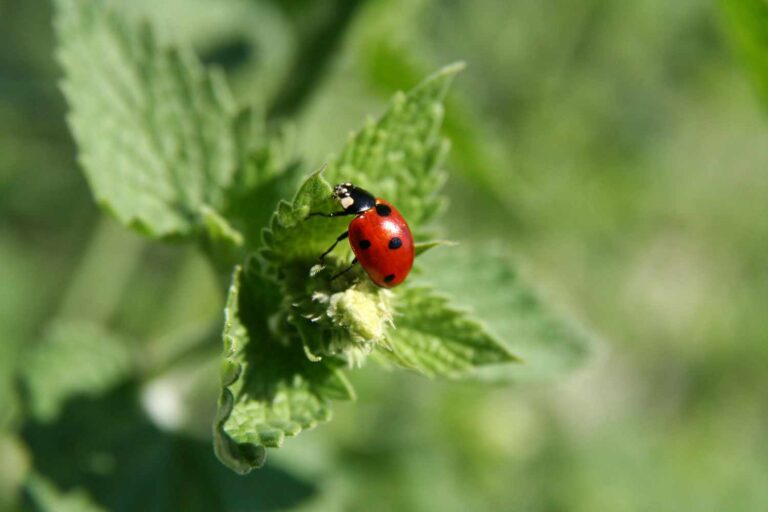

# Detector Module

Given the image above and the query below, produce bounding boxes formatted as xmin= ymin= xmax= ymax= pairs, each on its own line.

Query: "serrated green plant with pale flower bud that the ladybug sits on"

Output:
xmin=37 ymin=0 xmax=584 ymax=480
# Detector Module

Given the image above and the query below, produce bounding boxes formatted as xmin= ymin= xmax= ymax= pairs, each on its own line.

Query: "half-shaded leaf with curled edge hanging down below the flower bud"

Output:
xmin=214 ymin=265 xmax=354 ymax=473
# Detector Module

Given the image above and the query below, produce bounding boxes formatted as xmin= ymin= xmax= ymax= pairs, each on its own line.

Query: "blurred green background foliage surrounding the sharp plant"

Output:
xmin=0 ymin=0 xmax=768 ymax=511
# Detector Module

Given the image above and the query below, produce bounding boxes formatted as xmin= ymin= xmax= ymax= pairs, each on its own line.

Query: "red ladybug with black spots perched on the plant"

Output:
xmin=310 ymin=183 xmax=414 ymax=288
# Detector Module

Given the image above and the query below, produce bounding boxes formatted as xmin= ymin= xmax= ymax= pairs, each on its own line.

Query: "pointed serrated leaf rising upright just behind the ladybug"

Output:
xmin=325 ymin=64 xmax=464 ymax=229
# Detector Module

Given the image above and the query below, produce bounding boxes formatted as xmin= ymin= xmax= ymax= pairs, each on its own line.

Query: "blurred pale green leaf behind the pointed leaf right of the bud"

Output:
xmin=414 ymin=245 xmax=590 ymax=380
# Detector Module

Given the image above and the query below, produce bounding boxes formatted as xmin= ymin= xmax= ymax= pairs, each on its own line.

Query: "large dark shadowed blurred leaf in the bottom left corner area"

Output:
xmin=23 ymin=382 xmax=317 ymax=512
